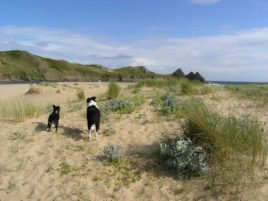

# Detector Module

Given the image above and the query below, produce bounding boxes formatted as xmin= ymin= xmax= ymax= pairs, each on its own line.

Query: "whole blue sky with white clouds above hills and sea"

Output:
xmin=0 ymin=0 xmax=268 ymax=82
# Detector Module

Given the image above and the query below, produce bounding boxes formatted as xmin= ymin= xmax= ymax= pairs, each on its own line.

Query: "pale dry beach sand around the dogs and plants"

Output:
xmin=0 ymin=83 xmax=268 ymax=201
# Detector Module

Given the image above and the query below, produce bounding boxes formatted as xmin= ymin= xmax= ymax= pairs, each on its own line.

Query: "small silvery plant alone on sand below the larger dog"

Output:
xmin=103 ymin=145 xmax=122 ymax=163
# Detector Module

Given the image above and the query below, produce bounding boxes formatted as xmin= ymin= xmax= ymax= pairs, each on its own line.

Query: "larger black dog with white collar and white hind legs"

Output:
xmin=87 ymin=96 xmax=101 ymax=141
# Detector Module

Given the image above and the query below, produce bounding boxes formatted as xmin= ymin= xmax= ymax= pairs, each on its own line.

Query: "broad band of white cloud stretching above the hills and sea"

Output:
xmin=0 ymin=26 xmax=268 ymax=81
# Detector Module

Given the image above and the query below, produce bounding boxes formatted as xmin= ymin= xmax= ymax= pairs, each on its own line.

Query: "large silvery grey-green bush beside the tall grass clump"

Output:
xmin=160 ymin=136 xmax=209 ymax=179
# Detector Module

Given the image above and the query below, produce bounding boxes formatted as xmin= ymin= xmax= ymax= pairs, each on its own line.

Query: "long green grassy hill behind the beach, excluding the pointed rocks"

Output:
xmin=0 ymin=50 xmax=164 ymax=81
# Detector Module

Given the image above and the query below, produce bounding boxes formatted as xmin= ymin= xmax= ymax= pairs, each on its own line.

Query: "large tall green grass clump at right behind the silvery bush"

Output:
xmin=181 ymin=98 xmax=267 ymax=190
